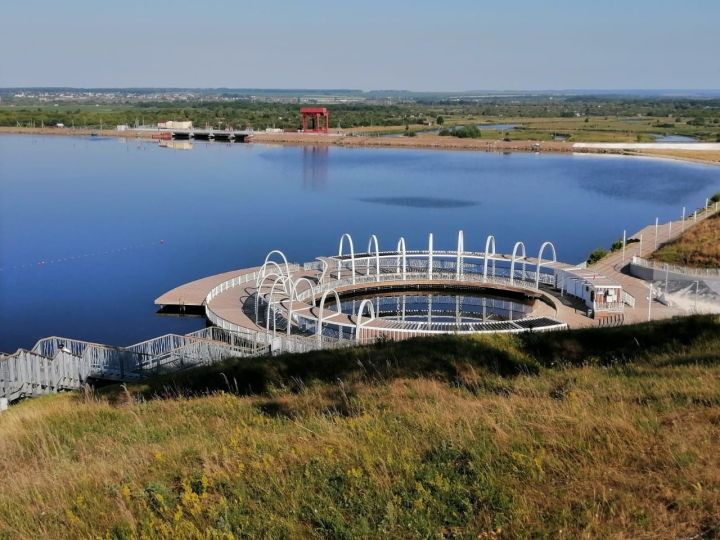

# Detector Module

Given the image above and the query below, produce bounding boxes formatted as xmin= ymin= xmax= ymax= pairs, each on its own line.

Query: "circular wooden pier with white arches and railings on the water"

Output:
xmin=155 ymin=231 xmax=577 ymax=352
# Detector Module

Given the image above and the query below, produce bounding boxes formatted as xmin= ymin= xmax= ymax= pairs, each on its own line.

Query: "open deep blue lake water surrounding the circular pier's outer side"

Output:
xmin=0 ymin=135 xmax=720 ymax=351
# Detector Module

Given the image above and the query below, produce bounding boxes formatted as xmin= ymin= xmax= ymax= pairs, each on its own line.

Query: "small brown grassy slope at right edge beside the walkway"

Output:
xmin=652 ymin=214 xmax=720 ymax=268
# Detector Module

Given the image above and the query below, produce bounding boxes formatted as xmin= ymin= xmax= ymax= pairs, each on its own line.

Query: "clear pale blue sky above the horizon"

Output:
xmin=0 ymin=0 xmax=720 ymax=90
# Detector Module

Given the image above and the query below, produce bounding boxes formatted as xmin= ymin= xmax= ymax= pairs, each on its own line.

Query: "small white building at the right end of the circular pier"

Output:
xmin=555 ymin=268 xmax=625 ymax=317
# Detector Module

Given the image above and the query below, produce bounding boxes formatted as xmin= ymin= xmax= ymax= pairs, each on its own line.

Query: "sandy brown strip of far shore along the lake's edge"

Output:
xmin=0 ymin=126 xmax=720 ymax=165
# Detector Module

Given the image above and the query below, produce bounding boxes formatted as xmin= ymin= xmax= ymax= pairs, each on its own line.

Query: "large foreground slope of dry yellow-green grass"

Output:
xmin=0 ymin=317 xmax=720 ymax=538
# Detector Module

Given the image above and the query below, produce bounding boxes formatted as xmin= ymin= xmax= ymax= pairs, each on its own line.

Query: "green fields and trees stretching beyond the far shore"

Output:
xmin=0 ymin=95 xmax=720 ymax=142
